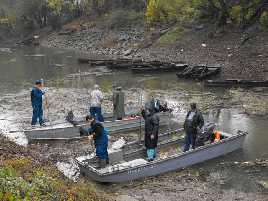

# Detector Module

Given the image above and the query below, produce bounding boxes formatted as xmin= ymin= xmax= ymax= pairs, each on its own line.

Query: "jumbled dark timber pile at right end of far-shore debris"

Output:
xmin=177 ymin=64 xmax=221 ymax=80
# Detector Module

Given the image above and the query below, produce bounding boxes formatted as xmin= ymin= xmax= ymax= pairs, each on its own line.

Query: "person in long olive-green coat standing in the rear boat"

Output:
xmin=113 ymin=87 xmax=125 ymax=120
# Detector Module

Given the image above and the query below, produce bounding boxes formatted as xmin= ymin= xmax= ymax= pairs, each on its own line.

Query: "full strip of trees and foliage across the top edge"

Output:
xmin=0 ymin=0 xmax=268 ymax=37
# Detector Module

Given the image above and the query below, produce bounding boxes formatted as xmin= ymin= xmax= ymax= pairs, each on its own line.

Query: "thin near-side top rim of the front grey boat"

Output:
xmin=75 ymin=132 xmax=247 ymax=177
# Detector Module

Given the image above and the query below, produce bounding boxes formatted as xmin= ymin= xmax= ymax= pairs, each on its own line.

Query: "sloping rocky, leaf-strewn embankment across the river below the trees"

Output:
xmin=42 ymin=16 xmax=268 ymax=80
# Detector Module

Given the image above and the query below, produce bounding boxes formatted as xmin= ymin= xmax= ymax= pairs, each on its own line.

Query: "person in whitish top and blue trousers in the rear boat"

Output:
xmin=89 ymin=84 xmax=104 ymax=122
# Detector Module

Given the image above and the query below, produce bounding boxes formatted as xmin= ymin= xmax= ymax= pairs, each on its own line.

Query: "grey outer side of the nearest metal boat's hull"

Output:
xmin=78 ymin=131 xmax=246 ymax=183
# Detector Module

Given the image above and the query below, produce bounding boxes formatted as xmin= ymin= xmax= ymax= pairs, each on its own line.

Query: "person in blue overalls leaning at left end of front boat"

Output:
xmin=79 ymin=115 xmax=109 ymax=168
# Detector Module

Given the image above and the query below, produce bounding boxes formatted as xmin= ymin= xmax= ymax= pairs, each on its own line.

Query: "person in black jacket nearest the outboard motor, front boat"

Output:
xmin=183 ymin=103 xmax=204 ymax=152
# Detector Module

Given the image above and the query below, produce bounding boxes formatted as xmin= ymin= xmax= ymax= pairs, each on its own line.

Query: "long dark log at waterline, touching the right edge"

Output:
xmin=204 ymin=79 xmax=268 ymax=87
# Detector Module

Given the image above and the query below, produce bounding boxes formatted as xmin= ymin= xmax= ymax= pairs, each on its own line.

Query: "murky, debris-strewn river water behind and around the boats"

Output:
xmin=0 ymin=47 xmax=268 ymax=196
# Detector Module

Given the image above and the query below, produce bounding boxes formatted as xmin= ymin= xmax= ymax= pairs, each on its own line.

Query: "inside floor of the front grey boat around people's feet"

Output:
xmin=80 ymin=131 xmax=227 ymax=173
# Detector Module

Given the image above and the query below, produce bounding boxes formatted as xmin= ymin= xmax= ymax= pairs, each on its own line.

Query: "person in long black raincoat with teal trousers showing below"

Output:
xmin=142 ymin=102 xmax=160 ymax=161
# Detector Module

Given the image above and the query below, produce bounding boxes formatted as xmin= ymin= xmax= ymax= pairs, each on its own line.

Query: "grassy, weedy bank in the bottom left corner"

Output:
xmin=0 ymin=139 xmax=107 ymax=201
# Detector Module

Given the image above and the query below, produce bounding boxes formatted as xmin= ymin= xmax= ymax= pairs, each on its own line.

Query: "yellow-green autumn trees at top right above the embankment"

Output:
xmin=146 ymin=0 xmax=268 ymax=29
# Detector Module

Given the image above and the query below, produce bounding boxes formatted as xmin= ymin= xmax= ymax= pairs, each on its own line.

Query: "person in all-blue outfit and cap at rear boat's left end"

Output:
xmin=31 ymin=80 xmax=46 ymax=127
